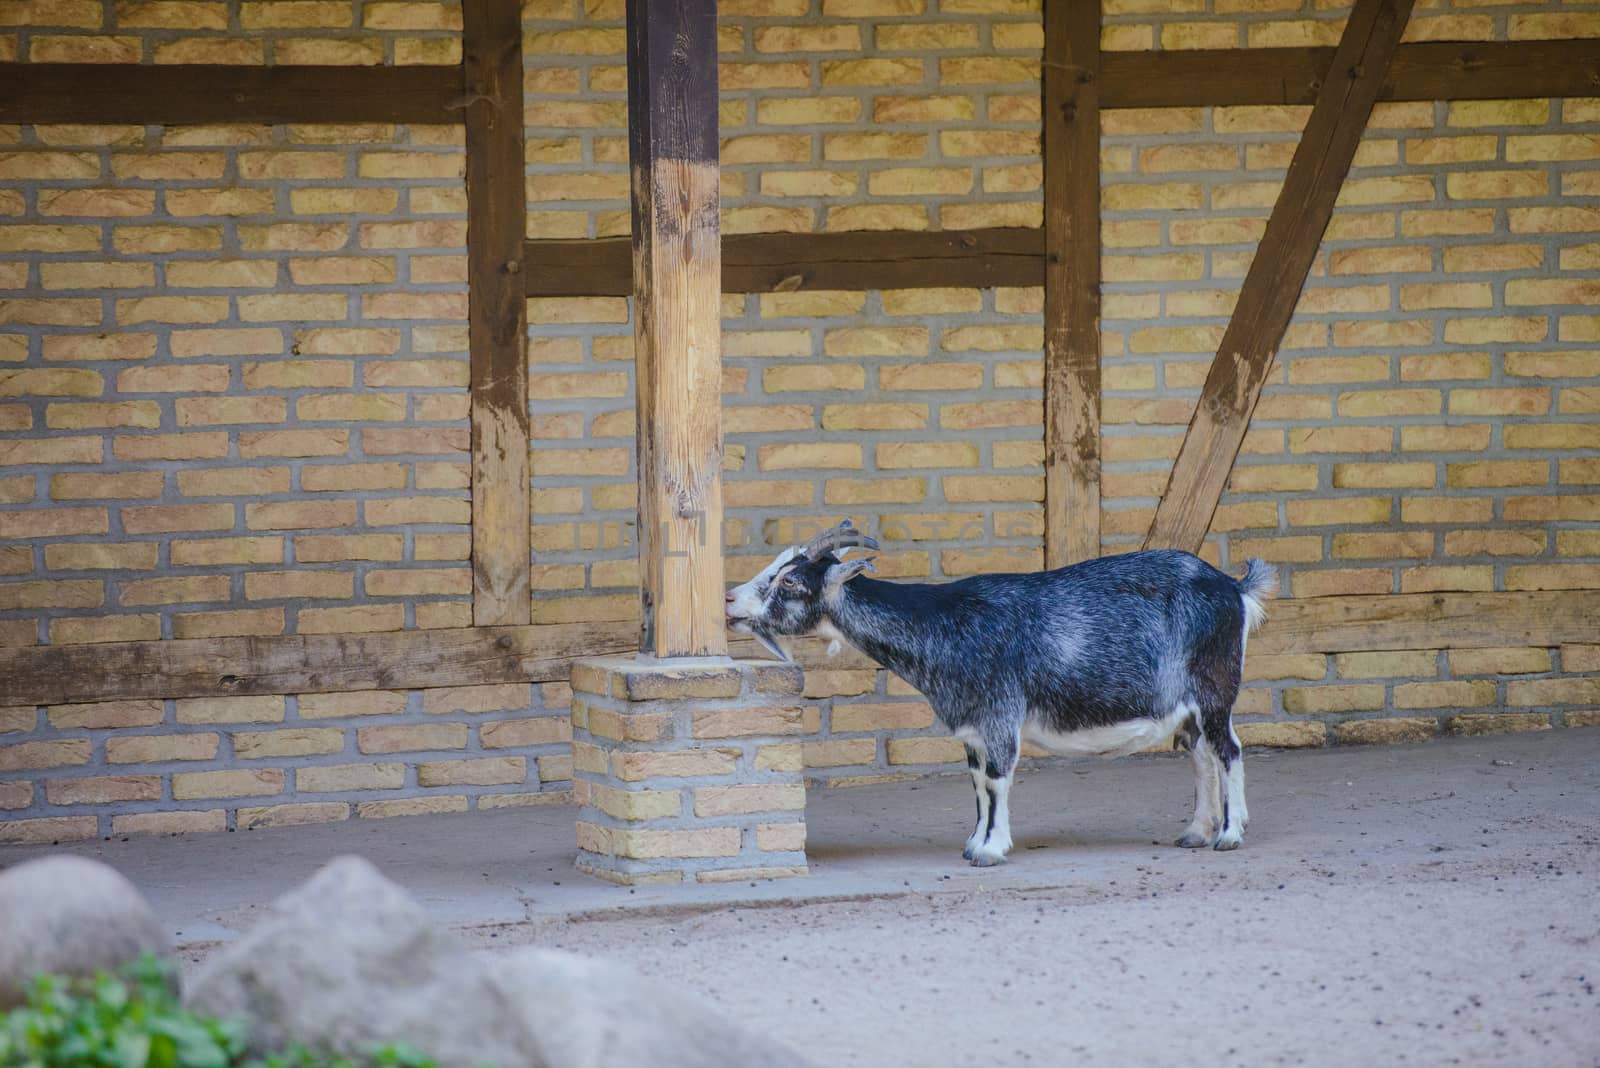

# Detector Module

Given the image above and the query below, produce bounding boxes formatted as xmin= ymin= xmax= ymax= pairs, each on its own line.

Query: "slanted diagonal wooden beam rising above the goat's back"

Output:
xmin=1144 ymin=0 xmax=1411 ymax=552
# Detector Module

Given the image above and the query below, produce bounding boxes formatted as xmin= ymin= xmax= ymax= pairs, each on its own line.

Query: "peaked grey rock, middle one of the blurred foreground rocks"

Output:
xmin=184 ymin=857 xmax=547 ymax=1068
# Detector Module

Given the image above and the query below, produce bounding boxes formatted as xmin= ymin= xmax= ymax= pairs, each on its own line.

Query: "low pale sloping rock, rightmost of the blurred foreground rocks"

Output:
xmin=488 ymin=948 xmax=810 ymax=1068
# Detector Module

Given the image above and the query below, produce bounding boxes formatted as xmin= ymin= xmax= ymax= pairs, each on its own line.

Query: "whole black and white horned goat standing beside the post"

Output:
xmin=726 ymin=520 xmax=1277 ymax=867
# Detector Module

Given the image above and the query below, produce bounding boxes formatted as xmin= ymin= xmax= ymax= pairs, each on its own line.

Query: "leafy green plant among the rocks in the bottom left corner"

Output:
xmin=0 ymin=954 xmax=437 ymax=1068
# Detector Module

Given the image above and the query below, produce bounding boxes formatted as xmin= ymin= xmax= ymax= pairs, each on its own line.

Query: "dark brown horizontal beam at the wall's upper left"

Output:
xmin=0 ymin=62 xmax=464 ymax=126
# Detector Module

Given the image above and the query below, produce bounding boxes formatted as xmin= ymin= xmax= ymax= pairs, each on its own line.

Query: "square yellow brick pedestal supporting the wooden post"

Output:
xmin=573 ymin=657 xmax=816 ymax=886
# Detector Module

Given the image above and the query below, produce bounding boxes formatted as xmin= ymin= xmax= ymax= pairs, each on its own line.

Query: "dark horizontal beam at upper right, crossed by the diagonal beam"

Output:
xmin=1101 ymin=40 xmax=1600 ymax=107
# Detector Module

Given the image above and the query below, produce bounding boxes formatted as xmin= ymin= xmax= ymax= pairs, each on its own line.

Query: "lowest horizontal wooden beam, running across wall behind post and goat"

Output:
xmin=0 ymin=590 xmax=1600 ymax=705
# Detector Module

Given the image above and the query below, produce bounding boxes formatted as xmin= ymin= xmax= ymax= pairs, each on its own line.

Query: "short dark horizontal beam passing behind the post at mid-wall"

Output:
xmin=523 ymin=227 xmax=1045 ymax=297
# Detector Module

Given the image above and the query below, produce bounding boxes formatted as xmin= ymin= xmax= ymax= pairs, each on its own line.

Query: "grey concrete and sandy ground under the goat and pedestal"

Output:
xmin=0 ymin=729 xmax=1600 ymax=1068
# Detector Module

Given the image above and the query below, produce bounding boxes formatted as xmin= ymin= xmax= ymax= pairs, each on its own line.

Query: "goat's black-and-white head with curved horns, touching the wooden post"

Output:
xmin=725 ymin=520 xmax=878 ymax=660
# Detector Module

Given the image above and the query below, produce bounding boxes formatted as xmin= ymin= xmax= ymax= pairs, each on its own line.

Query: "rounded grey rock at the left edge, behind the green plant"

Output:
xmin=0 ymin=855 xmax=171 ymax=1009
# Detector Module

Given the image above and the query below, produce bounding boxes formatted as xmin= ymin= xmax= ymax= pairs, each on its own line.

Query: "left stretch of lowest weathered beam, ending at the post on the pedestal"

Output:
xmin=0 ymin=622 xmax=638 ymax=705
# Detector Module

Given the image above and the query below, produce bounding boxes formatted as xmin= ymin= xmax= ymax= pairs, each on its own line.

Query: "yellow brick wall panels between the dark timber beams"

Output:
xmin=0 ymin=0 xmax=1600 ymax=838
